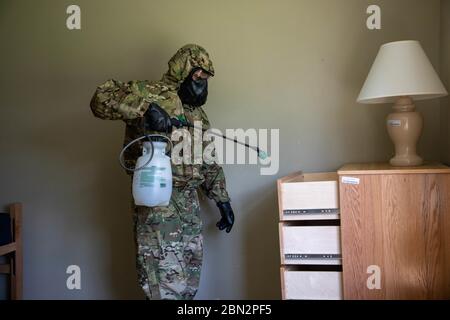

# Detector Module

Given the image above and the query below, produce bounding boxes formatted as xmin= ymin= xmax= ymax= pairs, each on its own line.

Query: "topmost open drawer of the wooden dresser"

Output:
xmin=278 ymin=172 xmax=339 ymax=221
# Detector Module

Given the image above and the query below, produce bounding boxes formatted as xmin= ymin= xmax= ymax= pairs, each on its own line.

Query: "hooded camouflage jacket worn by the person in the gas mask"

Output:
xmin=90 ymin=45 xmax=229 ymax=202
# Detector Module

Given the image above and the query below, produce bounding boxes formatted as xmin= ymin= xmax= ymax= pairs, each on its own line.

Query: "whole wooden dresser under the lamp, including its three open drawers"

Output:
xmin=278 ymin=163 xmax=450 ymax=299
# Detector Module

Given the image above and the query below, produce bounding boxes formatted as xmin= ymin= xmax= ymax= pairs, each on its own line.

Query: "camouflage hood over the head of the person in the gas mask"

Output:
xmin=162 ymin=44 xmax=214 ymax=88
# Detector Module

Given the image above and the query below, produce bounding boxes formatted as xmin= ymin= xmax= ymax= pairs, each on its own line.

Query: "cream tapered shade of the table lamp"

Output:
xmin=358 ymin=40 xmax=448 ymax=104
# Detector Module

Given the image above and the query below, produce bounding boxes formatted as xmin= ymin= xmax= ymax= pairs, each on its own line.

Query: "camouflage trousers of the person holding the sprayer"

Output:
xmin=134 ymin=188 xmax=203 ymax=300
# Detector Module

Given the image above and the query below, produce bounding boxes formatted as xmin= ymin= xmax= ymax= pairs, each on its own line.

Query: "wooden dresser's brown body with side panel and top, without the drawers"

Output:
xmin=338 ymin=164 xmax=450 ymax=299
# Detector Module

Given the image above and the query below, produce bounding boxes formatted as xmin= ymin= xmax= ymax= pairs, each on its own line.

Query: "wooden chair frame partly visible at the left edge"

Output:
xmin=0 ymin=203 xmax=23 ymax=300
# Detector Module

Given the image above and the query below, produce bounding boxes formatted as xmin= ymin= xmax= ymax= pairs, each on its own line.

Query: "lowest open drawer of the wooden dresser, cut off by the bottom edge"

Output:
xmin=281 ymin=268 xmax=343 ymax=300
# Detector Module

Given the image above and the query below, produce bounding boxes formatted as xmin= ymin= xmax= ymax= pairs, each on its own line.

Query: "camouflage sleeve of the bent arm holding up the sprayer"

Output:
xmin=90 ymin=80 xmax=152 ymax=120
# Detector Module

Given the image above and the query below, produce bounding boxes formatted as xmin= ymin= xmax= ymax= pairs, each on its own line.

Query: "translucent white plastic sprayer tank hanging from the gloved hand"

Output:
xmin=133 ymin=142 xmax=172 ymax=207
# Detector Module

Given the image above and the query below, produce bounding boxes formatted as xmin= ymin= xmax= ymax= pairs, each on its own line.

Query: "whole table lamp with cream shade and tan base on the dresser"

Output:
xmin=357 ymin=40 xmax=448 ymax=167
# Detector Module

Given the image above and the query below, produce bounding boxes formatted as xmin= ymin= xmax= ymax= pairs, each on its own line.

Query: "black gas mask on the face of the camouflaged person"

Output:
xmin=178 ymin=69 xmax=208 ymax=107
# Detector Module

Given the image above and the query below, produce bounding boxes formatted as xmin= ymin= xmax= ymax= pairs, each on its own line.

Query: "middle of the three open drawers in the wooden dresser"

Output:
xmin=280 ymin=223 xmax=341 ymax=265
